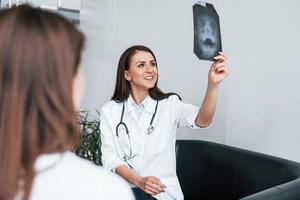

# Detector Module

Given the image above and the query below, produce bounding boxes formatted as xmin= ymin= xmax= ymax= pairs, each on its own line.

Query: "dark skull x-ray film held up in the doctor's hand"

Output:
xmin=193 ymin=2 xmax=222 ymax=61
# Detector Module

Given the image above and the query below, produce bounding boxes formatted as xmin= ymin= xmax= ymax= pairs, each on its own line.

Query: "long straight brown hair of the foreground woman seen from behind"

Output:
xmin=0 ymin=5 xmax=84 ymax=200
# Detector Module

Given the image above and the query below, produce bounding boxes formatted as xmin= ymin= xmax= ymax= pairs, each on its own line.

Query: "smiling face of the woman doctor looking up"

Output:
xmin=125 ymin=51 xmax=158 ymax=91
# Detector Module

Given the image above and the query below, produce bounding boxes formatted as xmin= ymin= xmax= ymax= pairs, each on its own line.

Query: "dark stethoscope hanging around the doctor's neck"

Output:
xmin=116 ymin=100 xmax=158 ymax=164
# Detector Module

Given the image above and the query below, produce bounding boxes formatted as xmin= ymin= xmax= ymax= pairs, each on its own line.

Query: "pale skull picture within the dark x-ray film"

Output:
xmin=195 ymin=15 xmax=220 ymax=58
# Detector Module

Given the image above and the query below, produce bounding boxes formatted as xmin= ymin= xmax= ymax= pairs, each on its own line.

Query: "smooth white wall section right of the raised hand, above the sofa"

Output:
xmin=226 ymin=0 xmax=300 ymax=161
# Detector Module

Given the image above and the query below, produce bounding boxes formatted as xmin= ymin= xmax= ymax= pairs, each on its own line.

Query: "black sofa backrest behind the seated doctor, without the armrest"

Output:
xmin=176 ymin=140 xmax=300 ymax=200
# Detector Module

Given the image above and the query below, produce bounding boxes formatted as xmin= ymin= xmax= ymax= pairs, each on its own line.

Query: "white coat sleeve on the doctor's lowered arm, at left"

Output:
xmin=100 ymin=109 xmax=128 ymax=172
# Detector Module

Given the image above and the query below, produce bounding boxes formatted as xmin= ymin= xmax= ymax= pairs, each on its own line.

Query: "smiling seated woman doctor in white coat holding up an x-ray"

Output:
xmin=100 ymin=46 xmax=228 ymax=200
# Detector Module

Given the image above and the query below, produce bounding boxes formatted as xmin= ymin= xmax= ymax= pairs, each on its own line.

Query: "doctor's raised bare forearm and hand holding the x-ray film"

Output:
xmin=195 ymin=52 xmax=228 ymax=127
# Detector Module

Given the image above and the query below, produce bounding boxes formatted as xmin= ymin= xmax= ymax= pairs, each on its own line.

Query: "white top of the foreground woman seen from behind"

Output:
xmin=30 ymin=152 xmax=135 ymax=200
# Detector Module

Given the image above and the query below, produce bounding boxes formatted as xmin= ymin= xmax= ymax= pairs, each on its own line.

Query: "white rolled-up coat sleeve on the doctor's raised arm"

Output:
xmin=174 ymin=97 xmax=210 ymax=129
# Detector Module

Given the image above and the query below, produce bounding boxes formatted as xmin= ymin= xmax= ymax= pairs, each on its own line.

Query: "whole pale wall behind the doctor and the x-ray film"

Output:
xmin=81 ymin=0 xmax=300 ymax=161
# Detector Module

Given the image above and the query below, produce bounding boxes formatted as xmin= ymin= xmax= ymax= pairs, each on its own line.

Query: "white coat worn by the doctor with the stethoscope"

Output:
xmin=100 ymin=95 xmax=207 ymax=200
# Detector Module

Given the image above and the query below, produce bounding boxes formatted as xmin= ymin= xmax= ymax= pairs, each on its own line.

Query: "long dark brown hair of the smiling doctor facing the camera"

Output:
xmin=111 ymin=45 xmax=180 ymax=103
